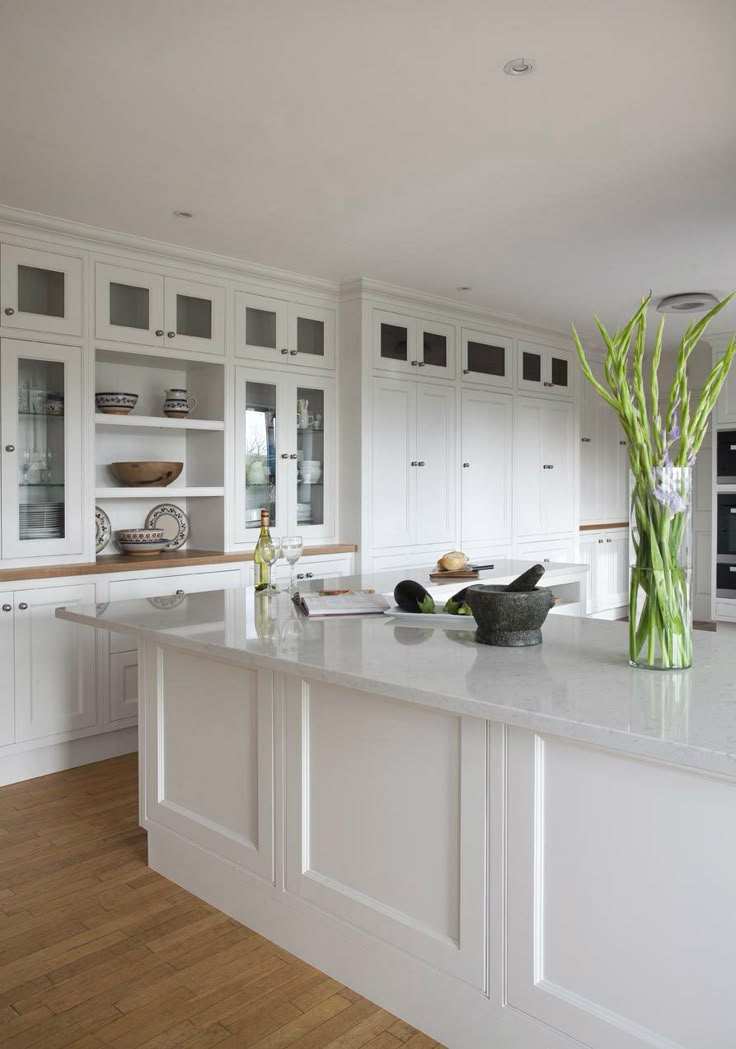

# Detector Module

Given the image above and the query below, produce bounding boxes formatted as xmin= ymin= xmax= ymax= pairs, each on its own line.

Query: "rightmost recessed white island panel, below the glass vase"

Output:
xmin=507 ymin=730 xmax=736 ymax=1049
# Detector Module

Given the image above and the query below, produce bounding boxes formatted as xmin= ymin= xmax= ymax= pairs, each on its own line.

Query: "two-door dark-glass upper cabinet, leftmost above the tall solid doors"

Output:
xmin=373 ymin=309 xmax=455 ymax=379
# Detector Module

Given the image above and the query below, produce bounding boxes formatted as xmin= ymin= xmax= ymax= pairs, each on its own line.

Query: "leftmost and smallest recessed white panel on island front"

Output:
xmin=146 ymin=646 xmax=274 ymax=880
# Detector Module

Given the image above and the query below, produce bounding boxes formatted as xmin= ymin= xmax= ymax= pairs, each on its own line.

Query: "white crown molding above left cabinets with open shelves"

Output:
xmin=0 ymin=204 xmax=340 ymax=297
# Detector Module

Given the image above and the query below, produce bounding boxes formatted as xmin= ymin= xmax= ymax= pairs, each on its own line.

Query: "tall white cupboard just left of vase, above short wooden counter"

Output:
xmin=580 ymin=363 xmax=629 ymax=525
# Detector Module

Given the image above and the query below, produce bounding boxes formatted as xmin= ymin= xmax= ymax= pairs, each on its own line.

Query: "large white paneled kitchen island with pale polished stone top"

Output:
xmin=58 ymin=565 xmax=736 ymax=1049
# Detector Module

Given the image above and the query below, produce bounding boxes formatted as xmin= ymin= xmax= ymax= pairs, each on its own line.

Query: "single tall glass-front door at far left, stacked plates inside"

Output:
xmin=0 ymin=339 xmax=83 ymax=558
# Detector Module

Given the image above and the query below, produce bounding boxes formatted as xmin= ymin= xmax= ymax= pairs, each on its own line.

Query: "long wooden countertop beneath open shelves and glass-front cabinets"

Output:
xmin=0 ymin=542 xmax=358 ymax=583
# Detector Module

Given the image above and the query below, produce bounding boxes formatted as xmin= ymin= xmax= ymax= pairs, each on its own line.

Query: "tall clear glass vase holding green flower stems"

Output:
xmin=629 ymin=466 xmax=693 ymax=670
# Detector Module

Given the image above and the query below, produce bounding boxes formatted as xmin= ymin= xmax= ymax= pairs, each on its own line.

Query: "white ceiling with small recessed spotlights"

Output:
xmin=0 ymin=0 xmax=736 ymax=344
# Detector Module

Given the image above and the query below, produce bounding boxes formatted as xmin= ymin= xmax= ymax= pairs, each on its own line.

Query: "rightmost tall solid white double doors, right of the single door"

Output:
xmin=514 ymin=397 xmax=576 ymax=540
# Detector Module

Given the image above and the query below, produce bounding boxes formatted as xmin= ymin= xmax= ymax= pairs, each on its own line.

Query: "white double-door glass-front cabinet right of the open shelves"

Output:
xmin=235 ymin=367 xmax=335 ymax=542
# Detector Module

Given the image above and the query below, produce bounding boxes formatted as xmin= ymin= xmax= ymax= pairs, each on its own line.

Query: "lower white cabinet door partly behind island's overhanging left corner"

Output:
xmin=15 ymin=583 xmax=96 ymax=742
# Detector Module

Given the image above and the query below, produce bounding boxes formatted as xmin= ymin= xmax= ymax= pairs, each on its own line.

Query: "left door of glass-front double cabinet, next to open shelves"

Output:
xmin=235 ymin=367 xmax=297 ymax=542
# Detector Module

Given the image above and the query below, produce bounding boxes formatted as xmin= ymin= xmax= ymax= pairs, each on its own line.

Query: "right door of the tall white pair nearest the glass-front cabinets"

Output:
xmin=414 ymin=383 xmax=457 ymax=543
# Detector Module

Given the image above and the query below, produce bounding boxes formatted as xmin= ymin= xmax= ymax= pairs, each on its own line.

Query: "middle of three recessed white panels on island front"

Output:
xmin=285 ymin=676 xmax=488 ymax=988
